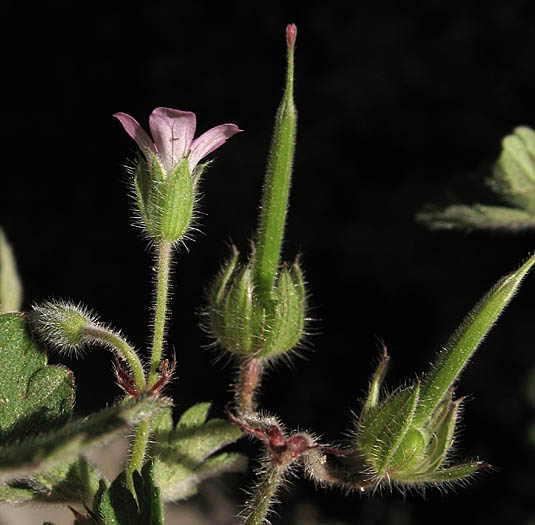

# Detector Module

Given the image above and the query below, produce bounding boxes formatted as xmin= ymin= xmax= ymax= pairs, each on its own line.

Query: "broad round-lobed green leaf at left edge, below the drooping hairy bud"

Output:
xmin=0 ymin=313 xmax=74 ymax=444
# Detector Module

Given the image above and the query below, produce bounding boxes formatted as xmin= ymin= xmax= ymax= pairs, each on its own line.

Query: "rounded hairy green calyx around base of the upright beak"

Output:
xmin=208 ymin=248 xmax=306 ymax=358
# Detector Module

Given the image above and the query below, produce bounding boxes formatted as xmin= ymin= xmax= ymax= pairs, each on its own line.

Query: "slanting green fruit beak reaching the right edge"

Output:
xmin=414 ymin=256 xmax=535 ymax=426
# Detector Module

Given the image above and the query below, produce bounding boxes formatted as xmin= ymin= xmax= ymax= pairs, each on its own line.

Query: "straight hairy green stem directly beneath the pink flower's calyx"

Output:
xmin=148 ymin=242 xmax=171 ymax=388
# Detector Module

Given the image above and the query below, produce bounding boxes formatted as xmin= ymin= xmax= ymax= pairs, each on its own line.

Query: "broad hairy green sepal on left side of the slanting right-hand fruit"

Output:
xmin=357 ymin=383 xmax=420 ymax=476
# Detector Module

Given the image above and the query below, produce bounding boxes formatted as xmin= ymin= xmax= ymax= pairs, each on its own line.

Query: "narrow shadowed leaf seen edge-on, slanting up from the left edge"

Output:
xmin=0 ymin=394 xmax=170 ymax=481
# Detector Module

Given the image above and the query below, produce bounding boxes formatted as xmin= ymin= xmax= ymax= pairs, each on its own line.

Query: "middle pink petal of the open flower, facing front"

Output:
xmin=149 ymin=108 xmax=197 ymax=170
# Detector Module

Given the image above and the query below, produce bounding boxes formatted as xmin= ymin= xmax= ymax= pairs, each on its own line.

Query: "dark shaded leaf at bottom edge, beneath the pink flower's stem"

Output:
xmin=95 ymin=459 xmax=163 ymax=525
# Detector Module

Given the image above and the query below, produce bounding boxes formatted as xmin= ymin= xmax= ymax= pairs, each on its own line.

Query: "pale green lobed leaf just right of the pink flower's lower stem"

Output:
xmin=152 ymin=403 xmax=247 ymax=501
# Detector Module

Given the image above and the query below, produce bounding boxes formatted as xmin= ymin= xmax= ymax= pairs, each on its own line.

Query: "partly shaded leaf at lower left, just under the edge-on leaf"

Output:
xmin=0 ymin=456 xmax=103 ymax=507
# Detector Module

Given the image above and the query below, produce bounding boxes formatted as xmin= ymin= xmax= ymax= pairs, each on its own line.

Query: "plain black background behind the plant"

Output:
xmin=0 ymin=0 xmax=535 ymax=525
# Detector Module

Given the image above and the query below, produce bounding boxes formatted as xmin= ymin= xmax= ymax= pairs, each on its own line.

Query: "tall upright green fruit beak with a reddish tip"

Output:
xmin=253 ymin=26 xmax=297 ymax=302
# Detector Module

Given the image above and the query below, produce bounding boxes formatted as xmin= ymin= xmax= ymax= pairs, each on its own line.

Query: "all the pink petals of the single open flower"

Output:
xmin=113 ymin=108 xmax=242 ymax=173
